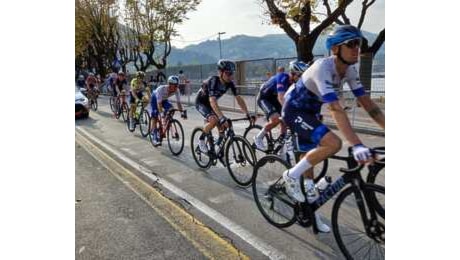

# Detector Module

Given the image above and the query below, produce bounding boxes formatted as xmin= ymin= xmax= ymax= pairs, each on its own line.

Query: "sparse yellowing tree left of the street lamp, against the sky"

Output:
xmin=125 ymin=0 xmax=201 ymax=71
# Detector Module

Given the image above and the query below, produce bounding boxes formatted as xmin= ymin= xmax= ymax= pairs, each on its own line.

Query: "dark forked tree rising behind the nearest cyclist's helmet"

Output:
xmin=262 ymin=0 xmax=353 ymax=62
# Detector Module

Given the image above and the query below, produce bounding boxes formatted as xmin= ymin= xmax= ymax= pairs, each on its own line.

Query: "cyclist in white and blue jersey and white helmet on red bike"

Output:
xmin=150 ymin=75 xmax=185 ymax=145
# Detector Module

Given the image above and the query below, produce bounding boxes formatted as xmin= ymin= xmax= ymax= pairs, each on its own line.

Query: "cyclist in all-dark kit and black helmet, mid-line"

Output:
xmin=195 ymin=59 xmax=254 ymax=153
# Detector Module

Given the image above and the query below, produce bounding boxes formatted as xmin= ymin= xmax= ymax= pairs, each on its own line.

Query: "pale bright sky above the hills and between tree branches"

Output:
xmin=172 ymin=0 xmax=385 ymax=48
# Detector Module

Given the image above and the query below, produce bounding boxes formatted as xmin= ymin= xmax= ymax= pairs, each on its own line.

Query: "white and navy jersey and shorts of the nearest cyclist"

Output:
xmin=282 ymin=56 xmax=365 ymax=152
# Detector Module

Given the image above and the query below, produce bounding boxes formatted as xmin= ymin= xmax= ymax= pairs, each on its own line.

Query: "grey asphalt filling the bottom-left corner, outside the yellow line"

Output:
xmin=75 ymin=143 xmax=206 ymax=259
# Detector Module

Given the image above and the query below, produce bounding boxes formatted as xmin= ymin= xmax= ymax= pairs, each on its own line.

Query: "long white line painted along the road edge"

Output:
xmin=76 ymin=126 xmax=287 ymax=259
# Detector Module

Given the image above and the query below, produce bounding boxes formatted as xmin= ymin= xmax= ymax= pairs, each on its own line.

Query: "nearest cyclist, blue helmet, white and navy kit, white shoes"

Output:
xmin=282 ymin=25 xmax=385 ymax=232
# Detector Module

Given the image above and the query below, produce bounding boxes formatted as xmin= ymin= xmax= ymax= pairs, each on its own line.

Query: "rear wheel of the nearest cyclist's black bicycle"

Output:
xmin=252 ymin=155 xmax=298 ymax=228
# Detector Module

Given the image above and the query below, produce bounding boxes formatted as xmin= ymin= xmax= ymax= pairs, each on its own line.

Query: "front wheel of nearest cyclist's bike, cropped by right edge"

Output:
xmin=332 ymin=184 xmax=385 ymax=259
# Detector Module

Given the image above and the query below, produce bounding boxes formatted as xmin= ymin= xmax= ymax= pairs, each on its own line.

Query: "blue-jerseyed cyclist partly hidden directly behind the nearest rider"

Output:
xmin=254 ymin=61 xmax=308 ymax=150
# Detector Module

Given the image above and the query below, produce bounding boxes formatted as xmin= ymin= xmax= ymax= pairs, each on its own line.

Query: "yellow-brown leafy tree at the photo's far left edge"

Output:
xmin=75 ymin=0 xmax=120 ymax=76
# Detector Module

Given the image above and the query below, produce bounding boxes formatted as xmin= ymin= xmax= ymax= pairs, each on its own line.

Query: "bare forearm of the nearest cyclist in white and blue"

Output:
xmin=328 ymin=100 xmax=362 ymax=146
